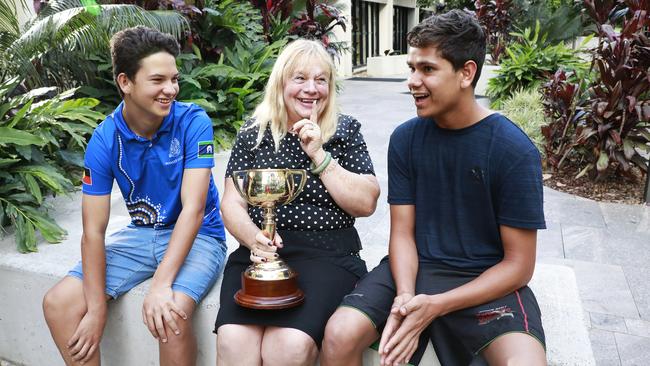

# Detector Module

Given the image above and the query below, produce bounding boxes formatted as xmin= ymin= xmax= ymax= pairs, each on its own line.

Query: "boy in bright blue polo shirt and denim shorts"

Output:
xmin=43 ymin=27 xmax=226 ymax=365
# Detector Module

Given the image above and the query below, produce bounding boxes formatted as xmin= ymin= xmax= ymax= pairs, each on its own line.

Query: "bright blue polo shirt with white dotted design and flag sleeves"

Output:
xmin=82 ymin=101 xmax=225 ymax=240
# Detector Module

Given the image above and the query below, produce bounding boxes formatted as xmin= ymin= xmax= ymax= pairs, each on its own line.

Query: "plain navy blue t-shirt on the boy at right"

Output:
xmin=388 ymin=113 xmax=546 ymax=270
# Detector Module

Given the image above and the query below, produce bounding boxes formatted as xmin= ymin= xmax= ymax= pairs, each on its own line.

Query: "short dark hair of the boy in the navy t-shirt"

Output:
xmin=406 ymin=9 xmax=485 ymax=87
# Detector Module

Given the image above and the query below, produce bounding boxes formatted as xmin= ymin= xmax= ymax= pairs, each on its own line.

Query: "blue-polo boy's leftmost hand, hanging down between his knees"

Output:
xmin=67 ymin=312 xmax=106 ymax=363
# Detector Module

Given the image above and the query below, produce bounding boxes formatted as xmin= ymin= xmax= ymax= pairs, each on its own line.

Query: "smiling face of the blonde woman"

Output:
xmin=283 ymin=62 xmax=330 ymax=125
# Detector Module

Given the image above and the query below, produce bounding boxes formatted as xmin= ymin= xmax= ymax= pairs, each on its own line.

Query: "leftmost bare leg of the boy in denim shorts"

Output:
xmin=43 ymin=276 xmax=110 ymax=365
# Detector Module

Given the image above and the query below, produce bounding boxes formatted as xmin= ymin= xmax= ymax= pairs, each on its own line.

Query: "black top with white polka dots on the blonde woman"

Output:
xmin=226 ymin=115 xmax=375 ymax=231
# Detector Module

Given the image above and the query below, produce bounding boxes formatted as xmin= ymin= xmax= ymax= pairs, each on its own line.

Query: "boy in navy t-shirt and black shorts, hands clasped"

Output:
xmin=321 ymin=10 xmax=546 ymax=366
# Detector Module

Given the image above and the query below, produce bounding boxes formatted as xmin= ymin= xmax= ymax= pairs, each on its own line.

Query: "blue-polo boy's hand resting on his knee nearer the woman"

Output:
xmin=142 ymin=286 xmax=187 ymax=343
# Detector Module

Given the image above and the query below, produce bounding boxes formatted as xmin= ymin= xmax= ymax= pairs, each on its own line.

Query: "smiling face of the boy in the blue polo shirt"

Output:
xmin=118 ymin=51 xmax=178 ymax=123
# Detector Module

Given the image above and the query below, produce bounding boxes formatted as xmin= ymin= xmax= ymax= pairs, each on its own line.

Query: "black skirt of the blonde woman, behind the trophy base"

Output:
xmin=214 ymin=228 xmax=367 ymax=348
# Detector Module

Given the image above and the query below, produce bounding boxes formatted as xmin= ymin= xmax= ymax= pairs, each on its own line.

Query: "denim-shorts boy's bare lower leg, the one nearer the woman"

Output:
xmin=158 ymin=291 xmax=197 ymax=366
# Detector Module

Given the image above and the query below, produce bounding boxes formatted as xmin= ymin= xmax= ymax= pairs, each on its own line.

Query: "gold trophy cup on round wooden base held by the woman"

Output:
xmin=232 ymin=169 xmax=307 ymax=309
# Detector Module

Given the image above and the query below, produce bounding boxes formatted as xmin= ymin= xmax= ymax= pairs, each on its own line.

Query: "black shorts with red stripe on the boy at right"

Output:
xmin=341 ymin=257 xmax=546 ymax=365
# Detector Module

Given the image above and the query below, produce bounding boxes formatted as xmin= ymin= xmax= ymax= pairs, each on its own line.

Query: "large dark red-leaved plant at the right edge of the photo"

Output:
xmin=542 ymin=0 xmax=650 ymax=179
